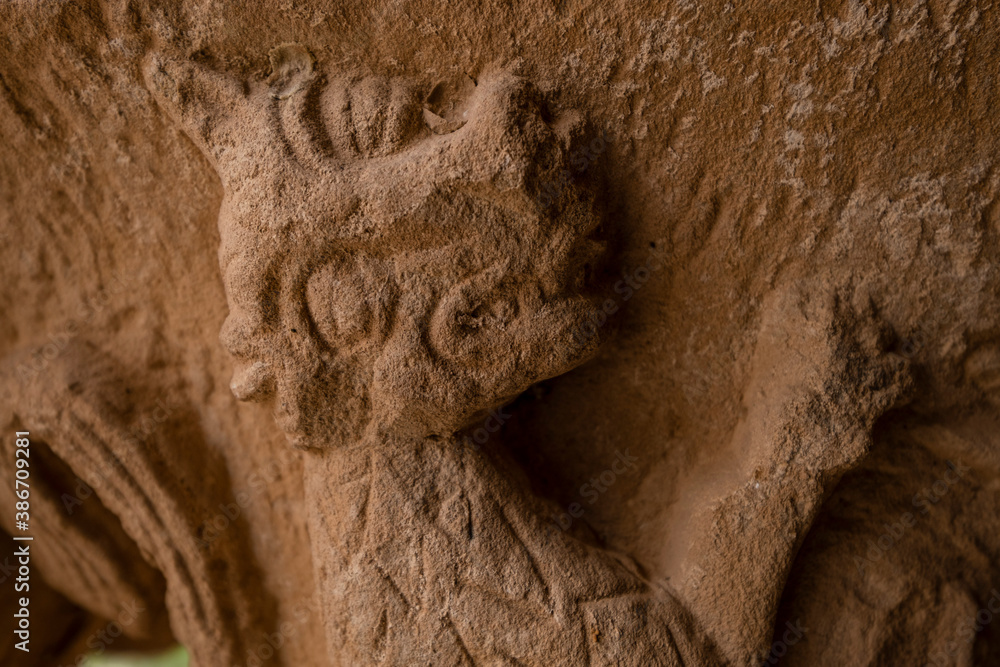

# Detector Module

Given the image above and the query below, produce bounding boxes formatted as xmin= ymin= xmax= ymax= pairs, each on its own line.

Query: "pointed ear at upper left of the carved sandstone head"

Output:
xmin=143 ymin=54 xmax=254 ymax=162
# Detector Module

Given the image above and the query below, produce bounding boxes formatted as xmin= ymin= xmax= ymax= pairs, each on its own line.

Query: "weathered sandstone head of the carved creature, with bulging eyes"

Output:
xmin=150 ymin=45 xmax=603 ymax=448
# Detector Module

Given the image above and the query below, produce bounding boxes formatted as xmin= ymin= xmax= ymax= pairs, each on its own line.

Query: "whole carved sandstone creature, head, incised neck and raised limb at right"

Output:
xmin=139 ymin=45 xmax=906 ymax=665
